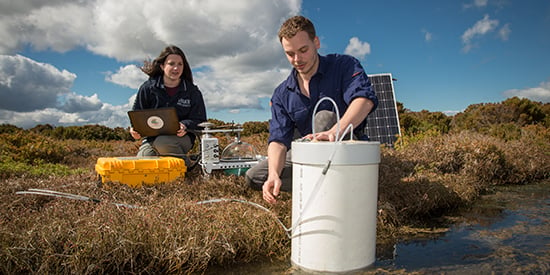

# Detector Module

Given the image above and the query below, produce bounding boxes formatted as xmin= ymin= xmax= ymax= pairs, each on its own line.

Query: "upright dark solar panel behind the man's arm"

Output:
xmin=364 ymin=73 xmax=401 ymax=147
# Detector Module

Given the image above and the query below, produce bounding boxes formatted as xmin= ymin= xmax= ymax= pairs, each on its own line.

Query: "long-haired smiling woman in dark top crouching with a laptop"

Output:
xmin=130 ymin=45 xmax=206 ymax=163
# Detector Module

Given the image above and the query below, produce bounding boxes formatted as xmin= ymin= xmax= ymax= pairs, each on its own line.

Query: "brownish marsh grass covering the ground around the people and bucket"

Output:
xmin=0 ymin=129 xmax=550 ymax=274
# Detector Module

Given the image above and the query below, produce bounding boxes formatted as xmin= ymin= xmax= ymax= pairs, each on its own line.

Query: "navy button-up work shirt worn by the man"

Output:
xmin=268 ymin=54 xmax=378 ymax=149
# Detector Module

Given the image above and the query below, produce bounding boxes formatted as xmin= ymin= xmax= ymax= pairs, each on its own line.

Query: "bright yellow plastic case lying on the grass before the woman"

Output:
xmin=95 ymin=157 xmax=187 ymax=187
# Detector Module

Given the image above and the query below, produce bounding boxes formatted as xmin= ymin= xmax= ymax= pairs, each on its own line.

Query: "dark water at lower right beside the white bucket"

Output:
xmin=209 ymin=181 xmax=550 ymax=274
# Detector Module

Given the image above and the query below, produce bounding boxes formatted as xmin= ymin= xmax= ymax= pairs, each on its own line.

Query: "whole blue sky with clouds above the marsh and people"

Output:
xmin=0 ymin=0 xmax=550 ymax=128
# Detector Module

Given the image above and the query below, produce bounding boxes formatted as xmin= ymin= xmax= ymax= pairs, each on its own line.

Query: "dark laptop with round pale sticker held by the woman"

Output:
xmin=128 ymin=107 xmax=180 ymax=137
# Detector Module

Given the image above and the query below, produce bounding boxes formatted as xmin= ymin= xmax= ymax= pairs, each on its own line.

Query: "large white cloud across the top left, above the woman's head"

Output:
xmin=0 ymin=0 xmax=301 ymax=71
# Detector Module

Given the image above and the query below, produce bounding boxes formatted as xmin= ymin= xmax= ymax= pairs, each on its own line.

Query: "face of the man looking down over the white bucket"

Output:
xmin=281 ymin=31 xmax=320 ymax=77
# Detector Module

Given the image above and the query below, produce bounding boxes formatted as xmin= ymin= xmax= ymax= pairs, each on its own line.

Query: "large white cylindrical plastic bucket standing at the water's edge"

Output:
xmin=291 ymin=140 xmax=380 ymax=272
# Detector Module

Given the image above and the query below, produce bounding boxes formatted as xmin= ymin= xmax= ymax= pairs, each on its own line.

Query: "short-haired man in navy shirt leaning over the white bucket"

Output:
xmin=246 ymin=16 xmax=378 ymax=203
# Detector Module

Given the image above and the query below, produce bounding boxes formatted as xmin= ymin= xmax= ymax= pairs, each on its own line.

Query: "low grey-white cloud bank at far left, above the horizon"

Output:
xmin=0 ymin=52 xmax=135 ymax=128
